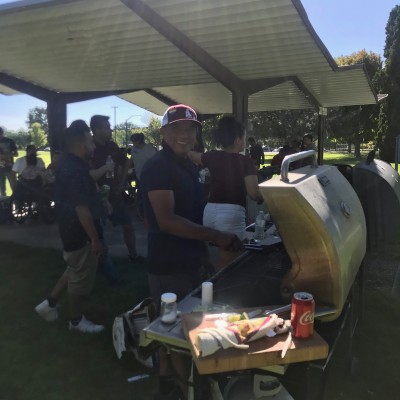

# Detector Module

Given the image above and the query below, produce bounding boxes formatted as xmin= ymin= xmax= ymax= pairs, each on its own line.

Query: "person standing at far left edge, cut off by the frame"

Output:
xmin=0 ymin=127 xmax=18 ymax=197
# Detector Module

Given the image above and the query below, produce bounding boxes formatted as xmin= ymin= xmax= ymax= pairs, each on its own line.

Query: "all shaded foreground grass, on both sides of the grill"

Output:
xmin=0 ymin=243 xmax=400 ymax=400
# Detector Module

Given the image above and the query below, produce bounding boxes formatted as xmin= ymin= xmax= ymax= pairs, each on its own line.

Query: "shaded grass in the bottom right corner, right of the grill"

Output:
xmin=325 ymin=288 xmax=400 ymax=400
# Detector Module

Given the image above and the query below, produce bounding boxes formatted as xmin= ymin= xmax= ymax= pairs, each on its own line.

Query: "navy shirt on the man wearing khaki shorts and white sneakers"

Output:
xmin=55 ymin=153 xmax=101 ymax=252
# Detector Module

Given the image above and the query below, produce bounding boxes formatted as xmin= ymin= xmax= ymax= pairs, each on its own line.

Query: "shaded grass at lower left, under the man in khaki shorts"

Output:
xmin=0 ymin=243 xmax=150 ymax=400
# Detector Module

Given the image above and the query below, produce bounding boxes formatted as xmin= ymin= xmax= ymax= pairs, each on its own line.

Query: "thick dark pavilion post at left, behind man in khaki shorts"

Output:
xmin=47 ymin=95 xmax=67 ymax=151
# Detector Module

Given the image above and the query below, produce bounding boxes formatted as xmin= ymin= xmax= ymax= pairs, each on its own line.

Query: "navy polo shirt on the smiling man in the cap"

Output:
xmin=141 ymin=144 xmax=204 ymax=275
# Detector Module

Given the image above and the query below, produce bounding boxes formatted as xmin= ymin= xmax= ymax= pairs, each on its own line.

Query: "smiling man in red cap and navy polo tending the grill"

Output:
xmin=141 ymin=104 xmax=242 ymax=399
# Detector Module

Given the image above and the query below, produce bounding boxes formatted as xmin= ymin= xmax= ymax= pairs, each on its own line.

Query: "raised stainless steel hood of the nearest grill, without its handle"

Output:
xmin=260 ymin=166 xmax=366 ymax=320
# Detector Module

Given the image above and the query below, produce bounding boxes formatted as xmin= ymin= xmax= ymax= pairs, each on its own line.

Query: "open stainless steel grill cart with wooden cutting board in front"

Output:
xmin=141 ymin=151 xmax=398 ymax=400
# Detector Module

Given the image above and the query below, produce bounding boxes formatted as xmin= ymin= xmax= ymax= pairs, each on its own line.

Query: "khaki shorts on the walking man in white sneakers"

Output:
xmin=64 ymin=243 xmax=98 ymax=295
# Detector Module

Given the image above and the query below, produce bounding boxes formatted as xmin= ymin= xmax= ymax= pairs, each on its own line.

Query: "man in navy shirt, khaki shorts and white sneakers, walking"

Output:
xmin=35 ymin=120 xmax=104 ymax=333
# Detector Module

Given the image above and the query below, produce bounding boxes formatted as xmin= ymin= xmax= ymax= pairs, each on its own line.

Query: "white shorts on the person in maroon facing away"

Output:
xmin=203 ymin=203 xmax=246 ymax=240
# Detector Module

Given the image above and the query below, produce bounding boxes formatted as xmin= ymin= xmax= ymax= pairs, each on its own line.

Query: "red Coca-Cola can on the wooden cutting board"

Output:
xmin=290 ymin=292 xmax=315 ymax=339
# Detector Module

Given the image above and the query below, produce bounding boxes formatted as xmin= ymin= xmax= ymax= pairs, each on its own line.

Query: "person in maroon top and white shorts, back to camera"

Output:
xmin=189 ymin=116 xmax=263 ymax=267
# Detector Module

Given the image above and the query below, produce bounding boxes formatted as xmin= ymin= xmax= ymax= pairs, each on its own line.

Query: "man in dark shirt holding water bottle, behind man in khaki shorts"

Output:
xmin=90 ymin=115 xmax=143 ymax=262
